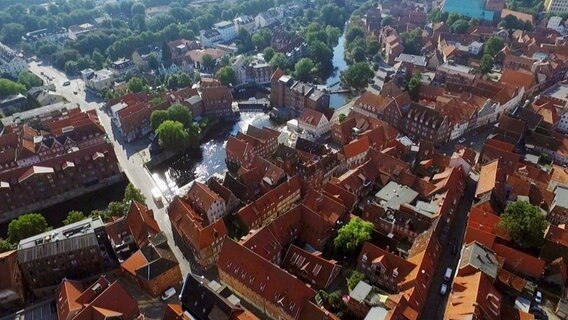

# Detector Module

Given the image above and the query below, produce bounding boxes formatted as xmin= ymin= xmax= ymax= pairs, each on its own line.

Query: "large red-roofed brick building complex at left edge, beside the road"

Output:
xmin=0 ymin=104 xmax=122 ymax=221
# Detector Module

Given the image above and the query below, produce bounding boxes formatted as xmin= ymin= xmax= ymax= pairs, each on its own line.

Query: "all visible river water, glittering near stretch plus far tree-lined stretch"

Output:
xmin=152 ymin=34 xmax=349 ymax=192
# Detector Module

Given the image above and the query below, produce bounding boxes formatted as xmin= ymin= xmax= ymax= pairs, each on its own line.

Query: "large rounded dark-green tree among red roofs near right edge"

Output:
xmin=499 ymin=201 xmax=548 ymax=248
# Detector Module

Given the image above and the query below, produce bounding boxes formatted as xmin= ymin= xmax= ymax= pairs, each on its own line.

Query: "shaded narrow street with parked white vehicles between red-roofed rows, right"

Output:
xmin=421 ymin=179 xmax=477 ymax=320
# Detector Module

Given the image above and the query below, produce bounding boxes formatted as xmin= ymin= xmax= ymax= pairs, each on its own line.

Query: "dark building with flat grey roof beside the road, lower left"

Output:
xmin=17 ymin=217 xmax=116 ymax=297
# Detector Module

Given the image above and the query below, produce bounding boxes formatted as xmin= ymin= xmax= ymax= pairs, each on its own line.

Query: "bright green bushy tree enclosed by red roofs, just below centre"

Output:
xmin=333 ymin=217 xmax=373 ymax=253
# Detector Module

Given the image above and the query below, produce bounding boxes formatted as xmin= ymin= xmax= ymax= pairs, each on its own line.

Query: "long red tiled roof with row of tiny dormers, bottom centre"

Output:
xmin=217 ymin=239 xmax=316 ymax=319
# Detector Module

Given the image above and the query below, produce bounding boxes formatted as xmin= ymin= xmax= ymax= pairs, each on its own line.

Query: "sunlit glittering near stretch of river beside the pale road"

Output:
xmin=152 ymin=112 xmax=276 ymax=197
